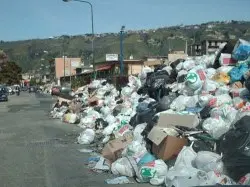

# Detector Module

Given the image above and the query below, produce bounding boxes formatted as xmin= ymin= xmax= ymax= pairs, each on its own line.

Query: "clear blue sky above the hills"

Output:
xmin=0 ymin=0 xmax=250 ymax=41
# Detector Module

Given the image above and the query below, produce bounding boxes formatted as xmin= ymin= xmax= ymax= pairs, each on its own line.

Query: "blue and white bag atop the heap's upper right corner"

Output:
xmin=232 ymin=39 xmax=250 ymax=61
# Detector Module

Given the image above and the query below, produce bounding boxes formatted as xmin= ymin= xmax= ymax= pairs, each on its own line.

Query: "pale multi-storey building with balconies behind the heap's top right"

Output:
xmin=201 ymin=40 xmax=228 ymax=55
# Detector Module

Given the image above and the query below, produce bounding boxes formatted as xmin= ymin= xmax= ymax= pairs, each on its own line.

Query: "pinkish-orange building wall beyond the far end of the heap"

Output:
xmin=55 ymin=58 xmax=81 ymax=79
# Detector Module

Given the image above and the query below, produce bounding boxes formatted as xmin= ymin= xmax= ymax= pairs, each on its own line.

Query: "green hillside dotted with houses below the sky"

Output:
xmin=0 ymin=21 xmax=250 ymax=72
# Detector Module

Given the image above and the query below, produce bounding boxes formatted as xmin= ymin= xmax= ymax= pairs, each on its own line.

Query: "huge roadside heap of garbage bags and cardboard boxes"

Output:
xmin=51 ymin=39 xmax=250 ymax=187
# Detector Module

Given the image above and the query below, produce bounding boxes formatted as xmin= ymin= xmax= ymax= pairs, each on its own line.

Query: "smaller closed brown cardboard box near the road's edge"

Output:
xmin=102 ymin=137 xmax=132 ymax=162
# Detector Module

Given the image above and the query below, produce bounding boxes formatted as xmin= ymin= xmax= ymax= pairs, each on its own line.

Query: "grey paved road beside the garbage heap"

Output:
xmin=0 ymin=93 xmax=149 ymax=187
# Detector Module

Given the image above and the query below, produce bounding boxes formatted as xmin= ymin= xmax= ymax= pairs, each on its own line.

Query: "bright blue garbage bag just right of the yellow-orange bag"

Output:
xmin=229 ymin=64 xmax=248 ymax=83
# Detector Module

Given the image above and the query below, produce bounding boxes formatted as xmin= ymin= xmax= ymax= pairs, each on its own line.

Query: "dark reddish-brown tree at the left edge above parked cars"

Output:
xmin=0 ymin=62 xmax=22 ymax=85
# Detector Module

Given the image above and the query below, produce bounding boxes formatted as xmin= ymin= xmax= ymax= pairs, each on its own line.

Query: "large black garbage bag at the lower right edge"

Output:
xmin=217 ymin=116 xmax=250 ymax=181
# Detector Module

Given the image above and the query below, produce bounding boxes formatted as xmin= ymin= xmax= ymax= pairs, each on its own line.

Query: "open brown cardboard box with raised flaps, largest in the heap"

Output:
xmin=148 ymin=113 xmax=199 ymax=160
